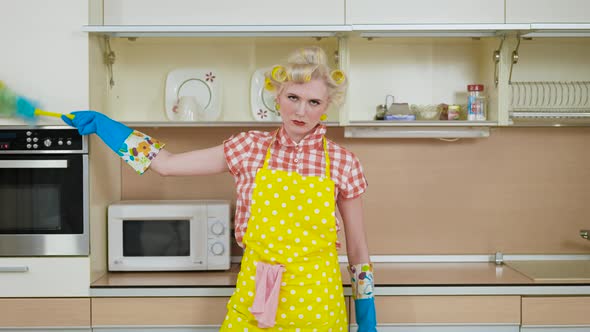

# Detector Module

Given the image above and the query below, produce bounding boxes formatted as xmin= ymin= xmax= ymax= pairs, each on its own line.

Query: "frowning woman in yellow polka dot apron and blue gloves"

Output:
xmin=62 ymin=47 xmax=376 ymax=332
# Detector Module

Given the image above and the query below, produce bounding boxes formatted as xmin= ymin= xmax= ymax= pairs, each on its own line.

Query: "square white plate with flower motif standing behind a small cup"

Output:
xmin=164 ymin=68 xmax=221 ymax=121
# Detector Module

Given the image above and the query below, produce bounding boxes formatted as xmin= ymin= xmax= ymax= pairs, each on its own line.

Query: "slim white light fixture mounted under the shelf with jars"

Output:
xmin=344 ymin=127 xmax=490 ymax=138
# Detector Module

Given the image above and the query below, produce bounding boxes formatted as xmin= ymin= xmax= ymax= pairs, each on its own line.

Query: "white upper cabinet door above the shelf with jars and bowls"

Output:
xmin=346 ymin=0 xmax=506 ymax=24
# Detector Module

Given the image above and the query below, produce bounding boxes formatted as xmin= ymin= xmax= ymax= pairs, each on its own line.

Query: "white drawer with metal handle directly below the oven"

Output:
xmin=0 ymin=257 xmax=90 ymax=297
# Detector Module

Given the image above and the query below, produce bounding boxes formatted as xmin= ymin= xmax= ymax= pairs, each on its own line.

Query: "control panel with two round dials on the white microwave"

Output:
xmin=207 ymin=203 xmax=231 ymax=270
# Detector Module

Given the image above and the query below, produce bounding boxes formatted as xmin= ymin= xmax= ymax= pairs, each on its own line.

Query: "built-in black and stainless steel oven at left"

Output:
xmin=0 ymin=127 xmax=89 ymax=257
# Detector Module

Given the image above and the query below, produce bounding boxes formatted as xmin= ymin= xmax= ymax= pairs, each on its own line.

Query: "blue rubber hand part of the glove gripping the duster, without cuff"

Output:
xmin=61 ymin=111 xmax=133 ymax=153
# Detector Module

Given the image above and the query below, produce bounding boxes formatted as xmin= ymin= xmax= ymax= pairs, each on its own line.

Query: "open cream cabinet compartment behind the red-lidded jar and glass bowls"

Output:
xmin=347 ymin=36 xmax=501 ymax=125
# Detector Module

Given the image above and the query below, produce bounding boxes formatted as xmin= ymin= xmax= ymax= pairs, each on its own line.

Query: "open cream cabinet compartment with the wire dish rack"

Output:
xmin=505 ymin=36 xmax=590 ymax=125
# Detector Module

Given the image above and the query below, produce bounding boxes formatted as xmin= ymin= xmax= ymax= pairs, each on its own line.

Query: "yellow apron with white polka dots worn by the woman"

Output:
xmin=221 ymin=137 xmax=348 ymax=332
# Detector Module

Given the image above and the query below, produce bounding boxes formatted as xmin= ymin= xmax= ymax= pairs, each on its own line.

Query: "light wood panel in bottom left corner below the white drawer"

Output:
xmin=0 ymin=298 xmax=91 ymax=332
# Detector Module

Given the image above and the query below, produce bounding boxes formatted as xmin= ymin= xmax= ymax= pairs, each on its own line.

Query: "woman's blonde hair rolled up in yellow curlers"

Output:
xmin=265 ymin=46 xmax=348 ymax=107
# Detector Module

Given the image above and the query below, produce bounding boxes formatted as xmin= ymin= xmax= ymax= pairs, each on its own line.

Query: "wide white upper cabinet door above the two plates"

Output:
xmin=104 ymin=0 xmax=344 ymax=25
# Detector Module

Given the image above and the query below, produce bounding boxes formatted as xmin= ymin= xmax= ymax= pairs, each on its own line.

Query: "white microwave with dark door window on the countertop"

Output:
xmin=107 ymin=200 xmax=231 ymax=271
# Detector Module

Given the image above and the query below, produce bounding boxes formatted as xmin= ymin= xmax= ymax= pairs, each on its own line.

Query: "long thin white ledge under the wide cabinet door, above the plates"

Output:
xmin=82 ymin=25 xmax=352 ymax=38
